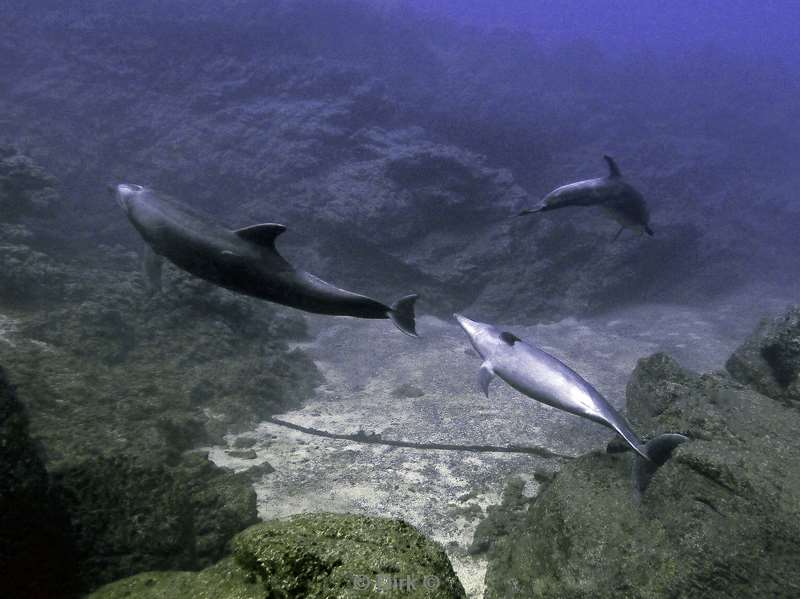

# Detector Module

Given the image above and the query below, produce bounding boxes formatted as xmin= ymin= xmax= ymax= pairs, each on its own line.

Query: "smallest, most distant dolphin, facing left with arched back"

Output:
xmin=518 ymin=156 xmax=653 ymax=240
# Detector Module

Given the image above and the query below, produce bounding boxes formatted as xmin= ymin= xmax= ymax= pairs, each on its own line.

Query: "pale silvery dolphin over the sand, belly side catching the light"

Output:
xmin=453 ymin=314 xmax=688 ymax=493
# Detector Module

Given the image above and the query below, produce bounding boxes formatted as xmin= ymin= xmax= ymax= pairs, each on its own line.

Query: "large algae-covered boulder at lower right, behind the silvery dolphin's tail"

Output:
xmin=486 ymin=344 xmax=800 ymax=599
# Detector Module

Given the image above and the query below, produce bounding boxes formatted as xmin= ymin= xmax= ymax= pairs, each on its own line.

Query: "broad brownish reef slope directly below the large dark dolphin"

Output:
xmin=0 ymin=265 xmax=321 ymax=462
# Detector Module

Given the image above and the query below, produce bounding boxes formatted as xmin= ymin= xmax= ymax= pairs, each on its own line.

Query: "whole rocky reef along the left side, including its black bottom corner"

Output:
xmin=0 ymin=154 xmax=321 ymax=597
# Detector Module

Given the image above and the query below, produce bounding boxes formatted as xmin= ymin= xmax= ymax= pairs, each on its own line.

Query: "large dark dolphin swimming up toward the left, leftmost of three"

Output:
xmin=115 ymin=183 xmax=418 ymax=337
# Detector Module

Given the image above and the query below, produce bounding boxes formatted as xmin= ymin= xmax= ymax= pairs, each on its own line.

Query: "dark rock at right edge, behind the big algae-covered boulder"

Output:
xmin=725 ymin=306 xmax=800 ymax=406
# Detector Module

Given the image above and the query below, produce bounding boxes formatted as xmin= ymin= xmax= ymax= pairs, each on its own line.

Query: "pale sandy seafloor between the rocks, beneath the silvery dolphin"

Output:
xmin=211 ymin=289 xmax=790 ymax=597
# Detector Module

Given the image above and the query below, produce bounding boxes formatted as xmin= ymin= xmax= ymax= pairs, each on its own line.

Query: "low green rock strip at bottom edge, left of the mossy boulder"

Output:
xmin=89 ymin=558 xmax=264 ymax=599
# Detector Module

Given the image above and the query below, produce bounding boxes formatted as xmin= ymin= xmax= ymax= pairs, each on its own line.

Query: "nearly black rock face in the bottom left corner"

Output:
xmin=0 ymin=368 xmax=79 ymax=599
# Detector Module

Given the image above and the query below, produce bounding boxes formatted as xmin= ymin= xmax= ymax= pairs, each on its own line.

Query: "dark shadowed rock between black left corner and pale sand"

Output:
xmin=53 ymin=454 xmax=258 ymax=589
